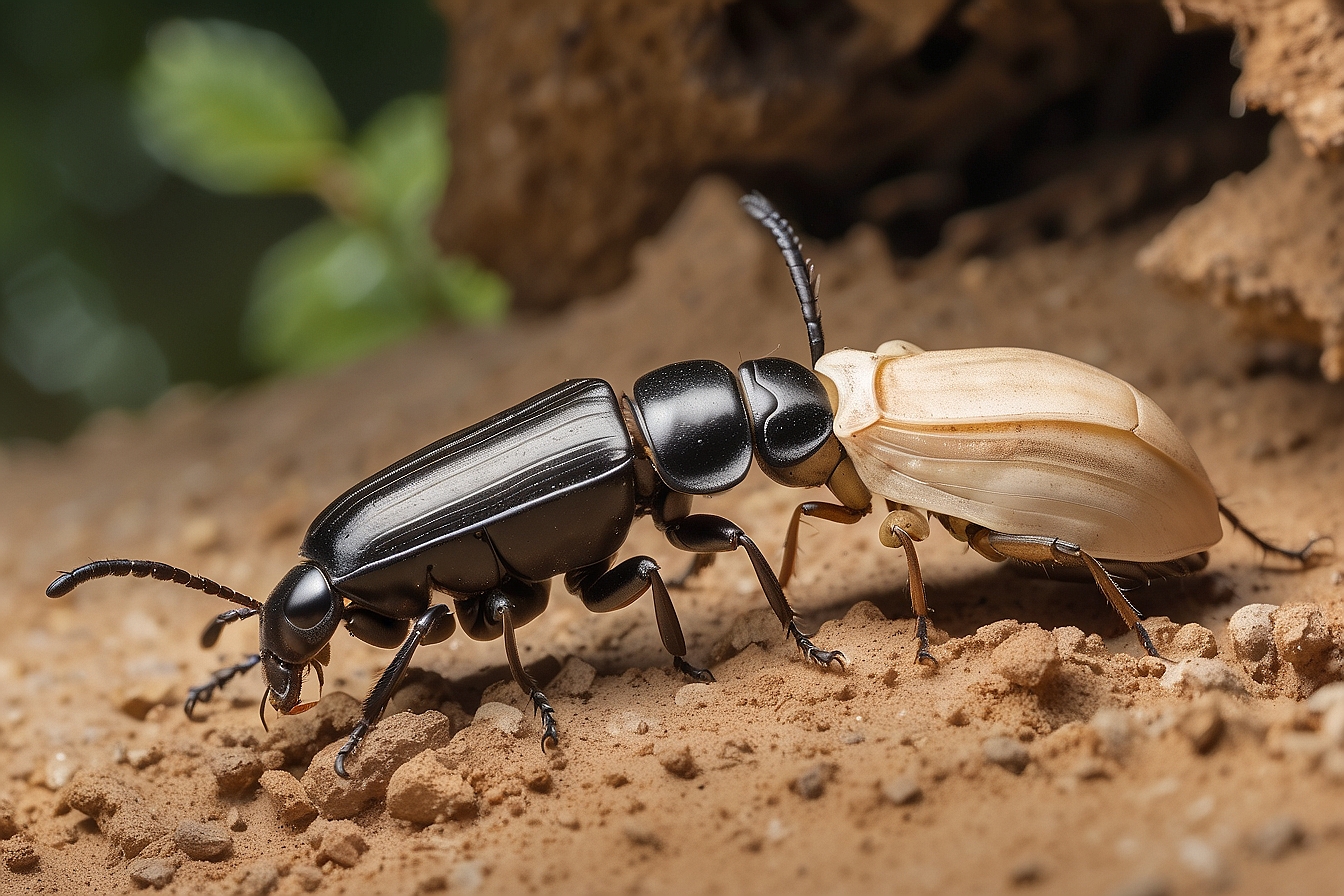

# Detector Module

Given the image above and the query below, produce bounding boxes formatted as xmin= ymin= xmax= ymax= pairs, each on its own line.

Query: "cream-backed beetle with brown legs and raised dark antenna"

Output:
xmin=742 ymin=193 xmax=1317 ymax=665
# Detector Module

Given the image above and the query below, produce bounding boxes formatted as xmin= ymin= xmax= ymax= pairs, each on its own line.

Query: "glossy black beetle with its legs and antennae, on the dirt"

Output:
xmin=47 ymin=200 xmax=845 ymax=776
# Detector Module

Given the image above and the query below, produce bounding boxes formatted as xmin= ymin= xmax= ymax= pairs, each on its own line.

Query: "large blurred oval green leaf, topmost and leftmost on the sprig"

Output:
xmin=134 ymin=19 xmax=344 ymax=192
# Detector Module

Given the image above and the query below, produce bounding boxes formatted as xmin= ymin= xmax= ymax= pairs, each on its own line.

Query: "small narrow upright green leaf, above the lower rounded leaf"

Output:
xmin=355 ymin=94 xmax=448 ymax=235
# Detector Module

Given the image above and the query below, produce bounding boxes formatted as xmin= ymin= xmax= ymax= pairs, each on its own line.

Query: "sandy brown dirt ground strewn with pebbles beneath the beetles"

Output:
xmin=0 ymin=180 xmax=1344 ymax=896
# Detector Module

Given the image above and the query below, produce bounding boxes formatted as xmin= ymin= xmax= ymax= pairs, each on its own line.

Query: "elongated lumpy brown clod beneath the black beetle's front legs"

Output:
xmin=302 ymin=709 xmax=453 ymax=818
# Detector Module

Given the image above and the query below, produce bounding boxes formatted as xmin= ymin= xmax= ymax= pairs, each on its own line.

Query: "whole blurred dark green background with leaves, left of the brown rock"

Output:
xmin=0 ymin=0 xmax=504 ymax=438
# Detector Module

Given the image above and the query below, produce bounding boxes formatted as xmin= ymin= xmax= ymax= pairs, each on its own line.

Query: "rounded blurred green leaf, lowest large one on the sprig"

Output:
xmin=243 ymin=218 xmax=429 ymax=371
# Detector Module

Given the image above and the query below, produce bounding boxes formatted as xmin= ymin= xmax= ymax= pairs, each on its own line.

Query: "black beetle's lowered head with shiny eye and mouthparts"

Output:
xmin=259 ymin=563 xmax=344 ymax=715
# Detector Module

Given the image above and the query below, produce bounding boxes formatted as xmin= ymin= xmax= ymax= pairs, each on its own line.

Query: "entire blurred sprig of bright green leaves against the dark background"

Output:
xmin=134 ymin=20 xmax=509 ymax=369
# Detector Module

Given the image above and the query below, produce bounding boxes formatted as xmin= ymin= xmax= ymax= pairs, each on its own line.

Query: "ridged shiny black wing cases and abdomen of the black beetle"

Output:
xmin=302 ymin=379 xmax=634 ymax=604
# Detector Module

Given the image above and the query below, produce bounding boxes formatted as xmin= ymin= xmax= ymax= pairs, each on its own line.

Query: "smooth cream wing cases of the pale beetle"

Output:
xmin=816 ymin=340 xmax=1222 ymax=563
